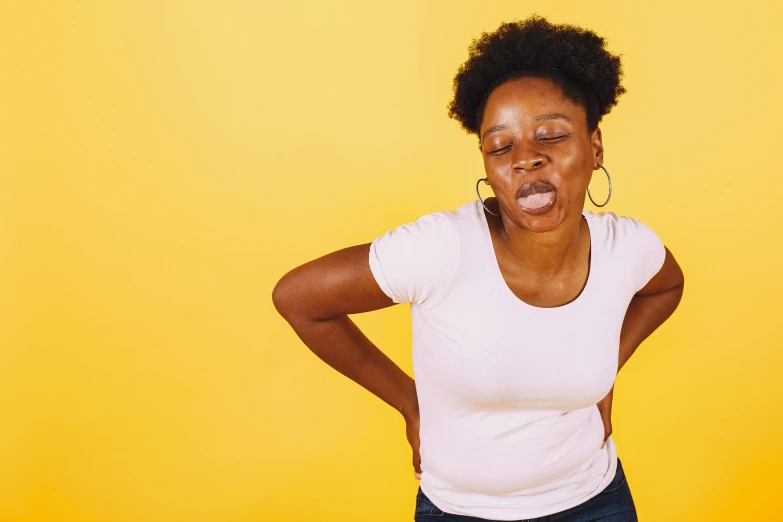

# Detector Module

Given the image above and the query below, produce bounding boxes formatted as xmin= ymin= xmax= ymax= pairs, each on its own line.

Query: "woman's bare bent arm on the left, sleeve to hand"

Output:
xmin=272 ymin=243 xmax=421 ymax=473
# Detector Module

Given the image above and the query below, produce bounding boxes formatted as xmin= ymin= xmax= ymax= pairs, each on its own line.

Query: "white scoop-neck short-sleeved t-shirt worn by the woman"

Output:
xmin=369 ymin=199 xmax=665 ymax=520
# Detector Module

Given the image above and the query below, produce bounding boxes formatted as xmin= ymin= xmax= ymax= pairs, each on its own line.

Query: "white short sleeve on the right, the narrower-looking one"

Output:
xmin=621 ymin=216 xmax=666 ymax=293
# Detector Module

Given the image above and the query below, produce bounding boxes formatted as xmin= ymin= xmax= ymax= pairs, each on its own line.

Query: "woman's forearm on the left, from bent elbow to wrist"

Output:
xmin=278 ymin=308 xmax=418 ymax=418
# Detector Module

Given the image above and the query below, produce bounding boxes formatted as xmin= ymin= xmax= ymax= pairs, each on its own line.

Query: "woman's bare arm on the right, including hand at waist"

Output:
xmin=598 ymin=248 xmax=685 ymax=447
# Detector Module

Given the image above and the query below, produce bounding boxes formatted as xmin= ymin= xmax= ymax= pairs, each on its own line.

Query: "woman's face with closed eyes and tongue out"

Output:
xmin=479 ymin=76 xmax=603 ymax=232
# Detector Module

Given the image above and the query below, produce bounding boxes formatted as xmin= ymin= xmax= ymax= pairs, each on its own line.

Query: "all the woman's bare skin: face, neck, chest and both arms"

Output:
xmin=272 ymin=77 xmax=684 ymax=478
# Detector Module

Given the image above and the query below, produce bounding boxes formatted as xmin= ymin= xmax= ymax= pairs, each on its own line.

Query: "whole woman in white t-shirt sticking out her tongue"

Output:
xmin=273 ymin=15 xmax=683 ymax=522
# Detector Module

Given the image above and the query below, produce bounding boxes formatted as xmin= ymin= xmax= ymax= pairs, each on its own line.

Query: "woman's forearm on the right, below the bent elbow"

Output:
xmin=617 ymin=285 xmax=683 ymax=372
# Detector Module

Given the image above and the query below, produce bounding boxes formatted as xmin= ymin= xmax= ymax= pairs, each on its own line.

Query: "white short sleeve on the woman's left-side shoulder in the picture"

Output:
xmin=369 ymin=212 xmax=459 ymax=306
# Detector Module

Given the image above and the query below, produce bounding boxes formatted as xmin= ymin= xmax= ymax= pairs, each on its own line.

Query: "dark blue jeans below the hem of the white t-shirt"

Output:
xmin=413 ymin=458 xmax=639 ymax=522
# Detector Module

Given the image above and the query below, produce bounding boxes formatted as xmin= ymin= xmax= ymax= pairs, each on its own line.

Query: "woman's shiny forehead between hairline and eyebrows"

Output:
xmin=481 ymin=76 xmax=584 ymax=124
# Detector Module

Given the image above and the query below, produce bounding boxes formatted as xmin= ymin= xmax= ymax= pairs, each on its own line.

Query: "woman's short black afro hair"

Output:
xmin=448 ymin=14 xmax=625 ymax=136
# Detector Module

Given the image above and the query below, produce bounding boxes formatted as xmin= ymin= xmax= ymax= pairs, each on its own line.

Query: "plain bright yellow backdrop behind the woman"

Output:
xmin=0 ymin=0 xmax=783 ymax=522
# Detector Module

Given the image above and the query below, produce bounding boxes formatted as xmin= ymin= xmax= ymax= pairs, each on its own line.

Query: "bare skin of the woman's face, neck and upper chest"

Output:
xmin=479 ymin=77 xmax=603 ymax=307
